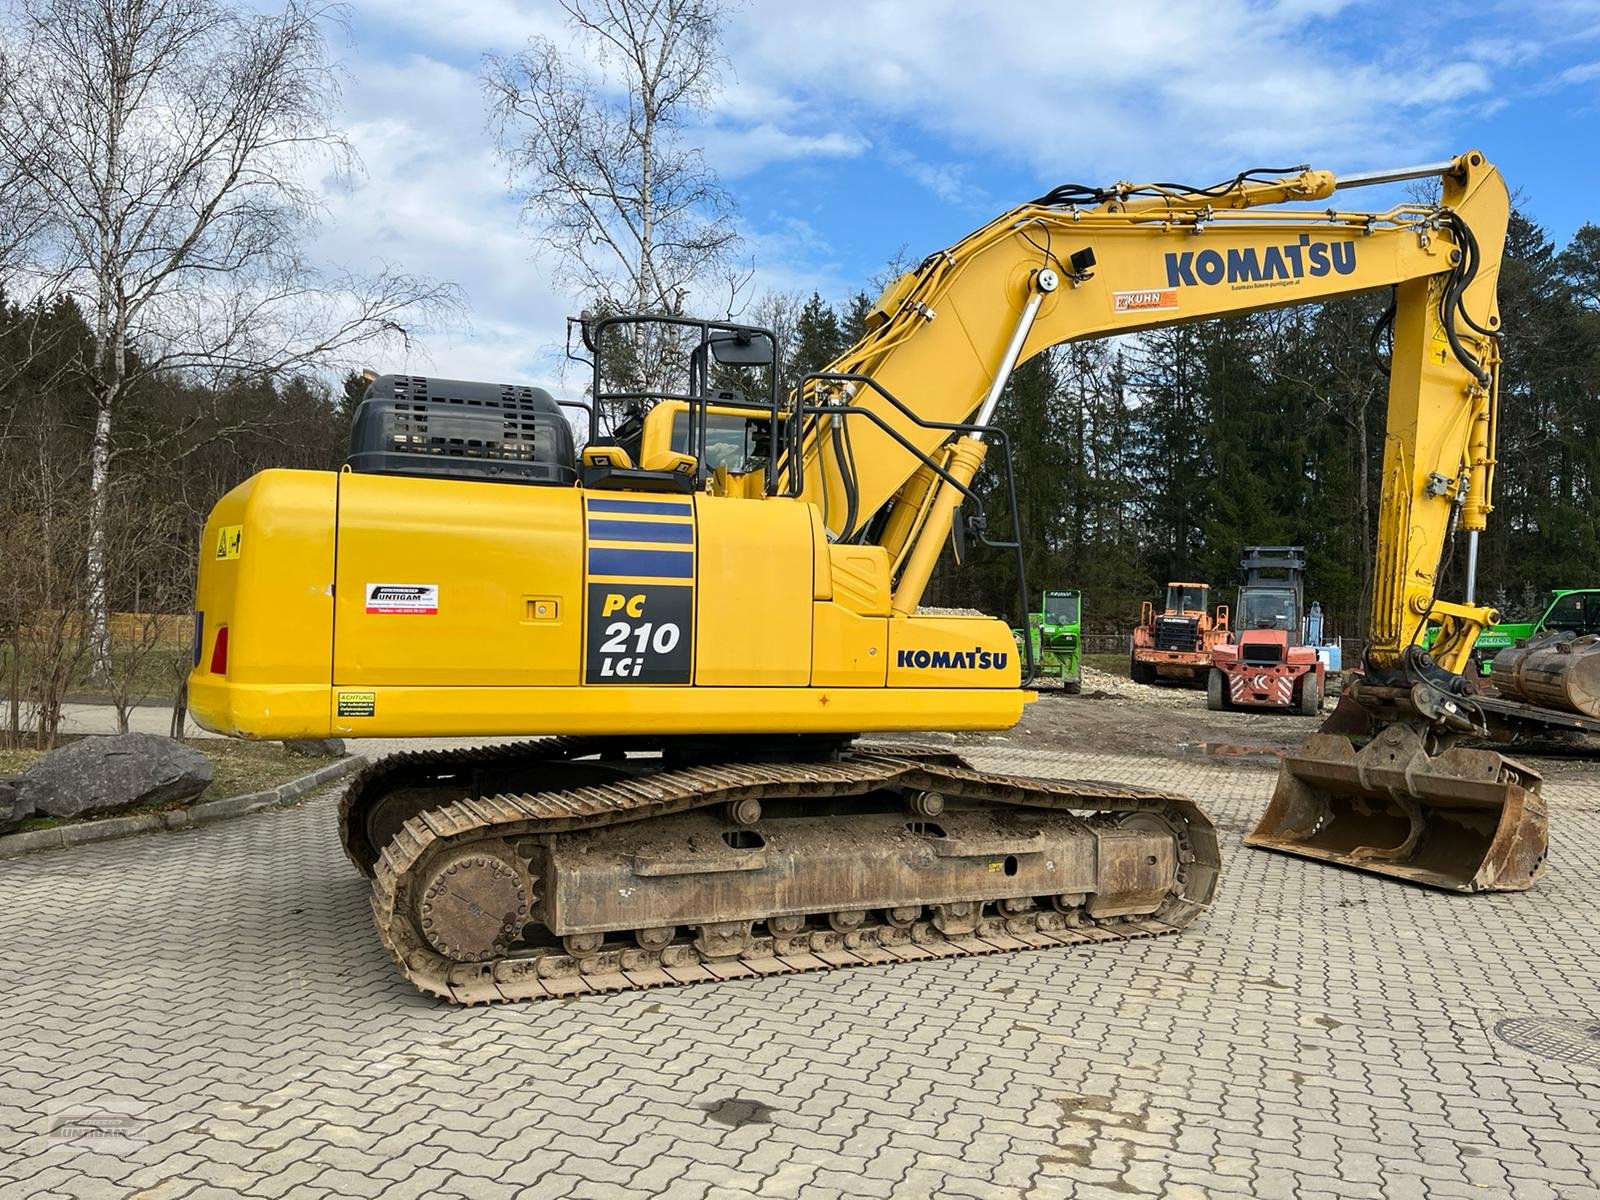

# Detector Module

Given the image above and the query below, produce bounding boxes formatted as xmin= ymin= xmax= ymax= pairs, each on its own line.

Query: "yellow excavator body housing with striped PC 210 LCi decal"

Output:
xmin=189 ymin=470 xmax=1011 ymax=738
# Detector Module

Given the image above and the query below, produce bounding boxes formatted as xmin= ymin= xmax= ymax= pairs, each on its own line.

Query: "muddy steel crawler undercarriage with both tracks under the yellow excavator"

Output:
xmin=339 ymin=739 xmax=1219 ymax=1005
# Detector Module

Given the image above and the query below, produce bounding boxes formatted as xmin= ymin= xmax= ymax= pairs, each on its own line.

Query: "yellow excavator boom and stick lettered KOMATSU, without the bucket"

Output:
xmin=768 ymin=152 xmax=1509 ymax=672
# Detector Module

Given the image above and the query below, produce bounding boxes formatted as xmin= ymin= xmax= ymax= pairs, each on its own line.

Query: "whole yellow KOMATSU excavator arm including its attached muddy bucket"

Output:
xmin=697 ymin=150 xmax=1546 ymax=890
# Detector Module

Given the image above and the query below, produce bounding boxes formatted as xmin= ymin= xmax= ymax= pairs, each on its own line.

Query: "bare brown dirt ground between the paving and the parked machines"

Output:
xmin=955 ymin=666 xmax=1600 ymax=778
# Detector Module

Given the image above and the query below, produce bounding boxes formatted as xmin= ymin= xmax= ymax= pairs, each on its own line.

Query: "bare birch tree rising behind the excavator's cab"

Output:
xmin=483 ymin=0 xmax=738 ymax=384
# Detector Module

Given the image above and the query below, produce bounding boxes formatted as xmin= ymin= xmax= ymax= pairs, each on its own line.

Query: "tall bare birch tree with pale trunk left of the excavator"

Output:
xmin=0 ymin=0 xmax=453 ymax=678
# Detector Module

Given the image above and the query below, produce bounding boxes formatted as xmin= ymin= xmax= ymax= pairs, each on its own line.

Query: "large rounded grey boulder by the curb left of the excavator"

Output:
xmin=18 ymin=733 xmax=211 ymax=816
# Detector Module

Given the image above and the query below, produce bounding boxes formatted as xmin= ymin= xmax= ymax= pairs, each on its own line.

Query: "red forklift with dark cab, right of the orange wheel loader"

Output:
xmin=1206 ymin=546 xmax=1326 ymax=717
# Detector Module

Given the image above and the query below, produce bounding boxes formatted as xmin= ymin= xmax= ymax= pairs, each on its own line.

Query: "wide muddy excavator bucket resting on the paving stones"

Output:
xmin=1245 ymin=725 xmax=1547 ymax=891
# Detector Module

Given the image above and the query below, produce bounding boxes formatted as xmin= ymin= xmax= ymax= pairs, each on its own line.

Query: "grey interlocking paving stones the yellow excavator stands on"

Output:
xmin=0 ymin=747 xmax=1600 ymax=1200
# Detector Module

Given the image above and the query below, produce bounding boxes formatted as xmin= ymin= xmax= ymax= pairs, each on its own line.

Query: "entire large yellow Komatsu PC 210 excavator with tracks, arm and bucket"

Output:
xmin=189 ymin=152 xmax=1544 ymax=1003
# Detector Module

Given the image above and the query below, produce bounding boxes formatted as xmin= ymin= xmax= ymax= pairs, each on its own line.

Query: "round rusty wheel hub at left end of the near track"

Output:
xmin=416 ymin=842 xmax=533 ymax=963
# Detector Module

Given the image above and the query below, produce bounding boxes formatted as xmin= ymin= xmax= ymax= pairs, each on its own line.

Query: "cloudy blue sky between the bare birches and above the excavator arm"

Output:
xmin=318 ymin=0 xmax=1600 ymax=390
